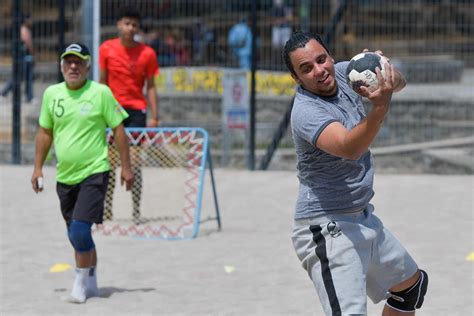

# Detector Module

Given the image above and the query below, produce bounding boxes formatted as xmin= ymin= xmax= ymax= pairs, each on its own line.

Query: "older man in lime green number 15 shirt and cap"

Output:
xmin=31 ymin=43 xmax=134 ymax=303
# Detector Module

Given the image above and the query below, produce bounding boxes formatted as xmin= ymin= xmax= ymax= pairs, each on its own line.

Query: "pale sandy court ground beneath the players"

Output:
xmin=0 ymin=165 xmax=474 ymax=316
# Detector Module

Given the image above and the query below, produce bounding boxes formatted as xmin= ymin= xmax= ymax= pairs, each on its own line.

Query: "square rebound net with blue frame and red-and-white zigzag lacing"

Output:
xmin=95 ymin=128 xmax=208 ymax=239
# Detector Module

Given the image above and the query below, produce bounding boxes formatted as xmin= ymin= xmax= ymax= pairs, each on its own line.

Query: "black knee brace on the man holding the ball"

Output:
xmin=387 ymin=270 xmax=428 ymax=312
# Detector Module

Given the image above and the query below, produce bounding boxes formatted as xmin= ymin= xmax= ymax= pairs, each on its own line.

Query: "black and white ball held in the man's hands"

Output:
xmin=346 ymin=52 xmax=388 ymax=93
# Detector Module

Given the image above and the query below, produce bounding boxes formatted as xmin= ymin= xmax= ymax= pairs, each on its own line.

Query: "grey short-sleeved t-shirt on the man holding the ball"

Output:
xmin=291 ymin=62 xmax=374 ymax=219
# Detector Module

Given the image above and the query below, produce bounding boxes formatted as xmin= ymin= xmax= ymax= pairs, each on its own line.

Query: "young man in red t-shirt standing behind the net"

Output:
xmin=99 ymin=6 xmax=159 ymax=223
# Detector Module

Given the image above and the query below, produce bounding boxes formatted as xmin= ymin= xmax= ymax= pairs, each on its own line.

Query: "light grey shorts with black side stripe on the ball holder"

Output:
xmin=292 ymin=205 xmax=418 ymax=315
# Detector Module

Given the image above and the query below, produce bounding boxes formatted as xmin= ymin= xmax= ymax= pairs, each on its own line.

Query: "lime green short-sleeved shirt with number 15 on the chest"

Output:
xmin=39 ymin=80 xmax=128 ymax=184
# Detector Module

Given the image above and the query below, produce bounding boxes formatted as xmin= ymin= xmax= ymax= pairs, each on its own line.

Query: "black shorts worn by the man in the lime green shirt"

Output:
xmin=56 ymin=171 xmax=109 ymax=226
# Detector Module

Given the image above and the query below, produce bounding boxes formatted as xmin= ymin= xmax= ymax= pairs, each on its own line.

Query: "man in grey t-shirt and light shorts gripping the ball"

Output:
xmin=283 ymin=32 xmax=428 ymax=315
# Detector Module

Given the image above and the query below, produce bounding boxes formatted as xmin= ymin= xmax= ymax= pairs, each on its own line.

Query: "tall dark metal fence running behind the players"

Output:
xmin=0 ymin=0 xmax=474 ymax=168
